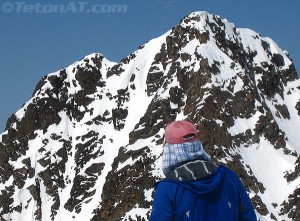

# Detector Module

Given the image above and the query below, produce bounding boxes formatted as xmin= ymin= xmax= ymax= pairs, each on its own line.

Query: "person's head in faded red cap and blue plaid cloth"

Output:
xmin=162 ymin=120 xmax=211 ymax=174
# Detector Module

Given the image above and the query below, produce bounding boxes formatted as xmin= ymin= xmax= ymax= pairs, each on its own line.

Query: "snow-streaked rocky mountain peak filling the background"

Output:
xmin=0 ymin=12 xmax=300 ymax=221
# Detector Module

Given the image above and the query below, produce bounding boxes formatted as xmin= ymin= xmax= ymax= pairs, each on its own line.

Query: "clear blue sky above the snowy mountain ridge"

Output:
xmin=0 ymin=0 xmax=300 ymax=133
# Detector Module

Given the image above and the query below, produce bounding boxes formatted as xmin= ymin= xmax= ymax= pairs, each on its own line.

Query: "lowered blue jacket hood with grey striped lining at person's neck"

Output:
xmin=157 ymin=160 xmax=226 ymax=195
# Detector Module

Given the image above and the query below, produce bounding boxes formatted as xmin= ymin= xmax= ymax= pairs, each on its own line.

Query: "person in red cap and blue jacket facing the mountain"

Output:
xmin=150 ymin=121 xmax=257 ymax=221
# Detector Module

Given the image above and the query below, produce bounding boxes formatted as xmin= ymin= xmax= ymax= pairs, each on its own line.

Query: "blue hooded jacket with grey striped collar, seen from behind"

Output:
xmin=150 ymin=160 xmax=257 ymax=221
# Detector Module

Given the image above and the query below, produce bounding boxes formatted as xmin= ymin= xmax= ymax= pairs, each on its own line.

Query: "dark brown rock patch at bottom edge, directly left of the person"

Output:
xmin=92 ymin=147 xmax=155 ymax=221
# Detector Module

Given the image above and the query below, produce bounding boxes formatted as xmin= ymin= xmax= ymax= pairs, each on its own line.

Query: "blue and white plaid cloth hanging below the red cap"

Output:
xmin=162 ymin=140 xmax=211 ymax=175
